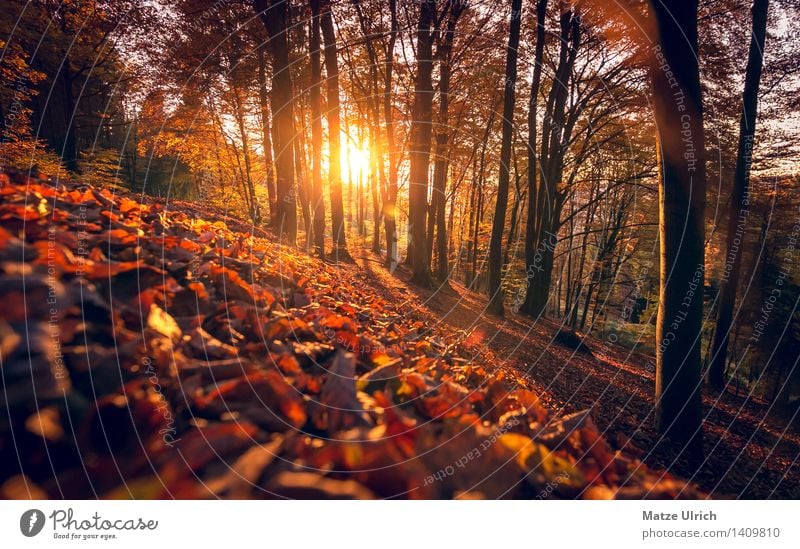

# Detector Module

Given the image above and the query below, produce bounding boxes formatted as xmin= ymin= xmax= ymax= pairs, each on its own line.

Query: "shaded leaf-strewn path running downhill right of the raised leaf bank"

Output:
xmin=357 ymin=245 xmax=800 ymax=499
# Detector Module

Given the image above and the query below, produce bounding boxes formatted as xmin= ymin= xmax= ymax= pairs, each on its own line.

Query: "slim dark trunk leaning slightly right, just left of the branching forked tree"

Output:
xmin=487 ymin=0 xmax=522 ymax=315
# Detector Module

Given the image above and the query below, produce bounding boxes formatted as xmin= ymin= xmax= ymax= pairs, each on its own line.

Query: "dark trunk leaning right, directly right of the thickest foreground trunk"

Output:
xmin=706 ymin=0 xmax=769 ymax=388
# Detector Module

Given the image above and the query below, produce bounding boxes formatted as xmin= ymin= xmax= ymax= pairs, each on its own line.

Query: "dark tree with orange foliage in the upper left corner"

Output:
xmin=0 ymin=0 xmax=149 ymax=173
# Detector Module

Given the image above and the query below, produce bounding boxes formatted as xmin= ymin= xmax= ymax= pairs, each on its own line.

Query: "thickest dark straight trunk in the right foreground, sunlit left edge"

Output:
xmin=650 ymin=0 xmax=706 ymax=458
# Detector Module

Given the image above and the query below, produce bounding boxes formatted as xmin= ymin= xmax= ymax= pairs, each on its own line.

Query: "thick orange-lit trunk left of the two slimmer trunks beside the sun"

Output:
xmin=254 ymin=0 xmax=297 ymax=245
